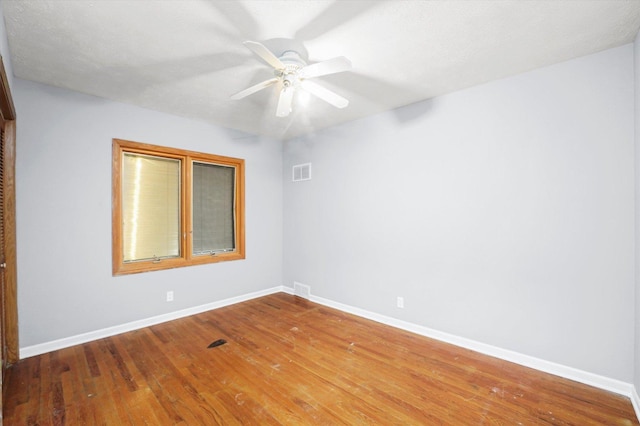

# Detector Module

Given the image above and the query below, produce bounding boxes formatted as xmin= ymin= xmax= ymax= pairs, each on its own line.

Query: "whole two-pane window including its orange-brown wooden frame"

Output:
xmin=112 ymin=139 xmax=245 ymax=275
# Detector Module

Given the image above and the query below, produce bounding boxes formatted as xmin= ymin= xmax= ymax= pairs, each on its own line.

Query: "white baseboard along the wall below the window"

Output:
xmin=20 ymin=286 xmax=285 ymax=359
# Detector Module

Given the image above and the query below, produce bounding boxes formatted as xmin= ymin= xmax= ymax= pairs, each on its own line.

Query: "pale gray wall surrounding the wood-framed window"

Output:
xmin=12 ymin=78 xmax=282 ymax=347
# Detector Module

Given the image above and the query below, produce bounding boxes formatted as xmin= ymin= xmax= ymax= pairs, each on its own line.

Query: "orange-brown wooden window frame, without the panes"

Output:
xmin=112 ymin=139 xmax=245 ymax=276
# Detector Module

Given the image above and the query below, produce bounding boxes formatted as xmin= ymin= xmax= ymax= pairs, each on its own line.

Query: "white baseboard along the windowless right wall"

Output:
xmin=283 ymin=287 xmax=640 ymax=404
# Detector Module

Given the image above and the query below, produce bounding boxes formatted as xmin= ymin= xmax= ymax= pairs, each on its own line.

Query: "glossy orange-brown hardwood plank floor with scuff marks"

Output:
xmin=4 ymin=293 xmax=638 ymax=425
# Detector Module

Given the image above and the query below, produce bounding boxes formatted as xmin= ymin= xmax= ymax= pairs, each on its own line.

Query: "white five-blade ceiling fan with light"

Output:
xmin=231 ymin=41 xmax=351 ymax=117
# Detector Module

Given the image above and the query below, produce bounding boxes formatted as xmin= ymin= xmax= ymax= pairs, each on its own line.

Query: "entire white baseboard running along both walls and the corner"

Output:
xmin=20 ymin=286 xmax=640 ymax=419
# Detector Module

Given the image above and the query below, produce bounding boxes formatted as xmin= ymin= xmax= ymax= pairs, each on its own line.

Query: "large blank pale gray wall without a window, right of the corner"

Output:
xmin=284 ymin=44 xmax=634 ymax=383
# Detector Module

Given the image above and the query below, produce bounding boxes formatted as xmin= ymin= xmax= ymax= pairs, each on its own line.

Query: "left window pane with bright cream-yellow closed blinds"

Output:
xmin=122 ymin=153 xmax=180 ymax=262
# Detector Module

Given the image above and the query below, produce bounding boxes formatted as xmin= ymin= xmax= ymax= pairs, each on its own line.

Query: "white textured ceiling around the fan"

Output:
xmin=1 ymin=0 xmax=640 ymax=139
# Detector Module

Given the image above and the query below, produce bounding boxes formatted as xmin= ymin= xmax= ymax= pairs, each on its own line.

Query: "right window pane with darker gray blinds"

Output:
xmin=192 ymin=162 xmax=235 ymax=254
